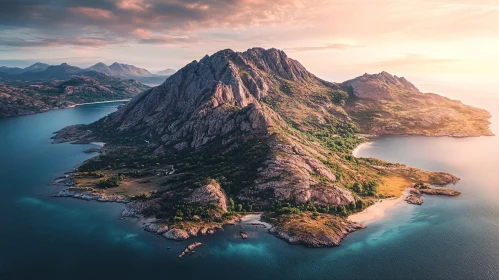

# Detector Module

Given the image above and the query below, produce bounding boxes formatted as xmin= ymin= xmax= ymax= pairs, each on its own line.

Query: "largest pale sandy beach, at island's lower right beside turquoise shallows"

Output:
xmin=348 ymin=189 xmax=409 ymax=225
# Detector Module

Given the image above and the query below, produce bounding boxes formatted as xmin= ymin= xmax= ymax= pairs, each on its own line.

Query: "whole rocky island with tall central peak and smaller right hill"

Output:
xmin=55 ymin=48 xmax=491 ymax=247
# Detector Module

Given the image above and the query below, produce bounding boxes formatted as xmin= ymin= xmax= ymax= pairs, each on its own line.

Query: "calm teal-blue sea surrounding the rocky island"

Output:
xmin=0 ymin=96 xmax=499 ymax=279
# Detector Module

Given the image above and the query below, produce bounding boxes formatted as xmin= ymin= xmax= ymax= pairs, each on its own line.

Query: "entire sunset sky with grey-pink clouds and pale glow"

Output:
xmin=0 ymin=0 xmax=499 ymax=86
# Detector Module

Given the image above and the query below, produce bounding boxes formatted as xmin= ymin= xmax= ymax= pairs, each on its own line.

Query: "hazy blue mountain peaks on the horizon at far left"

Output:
xmin=0 ymin=62 xmax=175 ymax=85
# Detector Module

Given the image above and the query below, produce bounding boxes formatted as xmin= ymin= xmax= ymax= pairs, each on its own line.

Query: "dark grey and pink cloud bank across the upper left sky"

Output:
xmin=0 ymin=0 xmax=305 ymax=47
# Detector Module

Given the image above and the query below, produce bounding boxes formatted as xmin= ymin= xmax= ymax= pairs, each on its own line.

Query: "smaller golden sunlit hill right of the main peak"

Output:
xmin=342 ymin=72 xmax=492 ymax=137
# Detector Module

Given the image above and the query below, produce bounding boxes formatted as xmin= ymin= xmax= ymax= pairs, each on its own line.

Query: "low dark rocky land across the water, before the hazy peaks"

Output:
xmin=0 ymin=73 xmax=148 ymax=118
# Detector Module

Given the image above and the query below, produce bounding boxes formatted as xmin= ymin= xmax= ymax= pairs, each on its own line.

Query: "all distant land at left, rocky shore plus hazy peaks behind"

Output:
xmin=0 ymin=63 xmax=154 ymax=118
